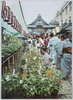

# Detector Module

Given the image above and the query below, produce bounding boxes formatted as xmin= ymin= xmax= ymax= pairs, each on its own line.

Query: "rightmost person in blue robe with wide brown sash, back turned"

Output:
xmin=58 ymin=35 xmax=72 ymax=80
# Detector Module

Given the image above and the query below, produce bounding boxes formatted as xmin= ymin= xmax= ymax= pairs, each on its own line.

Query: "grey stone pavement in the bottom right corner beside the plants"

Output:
xmin=57 ymin=70 xmax=72 ymax=99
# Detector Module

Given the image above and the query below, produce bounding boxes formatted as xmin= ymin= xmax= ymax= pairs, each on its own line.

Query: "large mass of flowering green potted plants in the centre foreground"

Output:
xmin=2 ymin=48 xmax=62 ymax=97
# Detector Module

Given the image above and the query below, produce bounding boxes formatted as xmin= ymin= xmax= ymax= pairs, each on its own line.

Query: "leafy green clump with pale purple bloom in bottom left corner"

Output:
xmin=1 ymin=73 xmax=21 ymax=93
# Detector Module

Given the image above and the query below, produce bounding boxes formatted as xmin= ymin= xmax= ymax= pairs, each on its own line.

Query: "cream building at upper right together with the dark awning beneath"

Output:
xmin=52 ymin=1 xmax=72 ymax=34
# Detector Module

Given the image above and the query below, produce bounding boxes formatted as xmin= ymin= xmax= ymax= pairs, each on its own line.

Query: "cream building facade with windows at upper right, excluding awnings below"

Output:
xmin=53 ymin=1 xmax=72 ymax=26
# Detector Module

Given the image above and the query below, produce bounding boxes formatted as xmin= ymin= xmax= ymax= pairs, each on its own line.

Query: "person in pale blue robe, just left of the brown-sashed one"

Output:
xmin=47 ymin=33 xmax=59 ymax=64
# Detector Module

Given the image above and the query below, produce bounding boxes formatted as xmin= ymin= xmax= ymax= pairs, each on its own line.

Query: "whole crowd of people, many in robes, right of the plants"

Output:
xmin=25 ymin=33 xmax=72 ymax=80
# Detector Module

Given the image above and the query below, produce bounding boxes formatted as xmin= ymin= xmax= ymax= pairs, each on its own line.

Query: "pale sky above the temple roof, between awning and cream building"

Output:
xmin=6 ymin=0 xmax=67 ymax=24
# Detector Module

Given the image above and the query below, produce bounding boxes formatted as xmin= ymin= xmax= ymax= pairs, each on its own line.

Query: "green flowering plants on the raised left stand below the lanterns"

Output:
xmin=2 ymin=34 xmax=21 ymax=57
